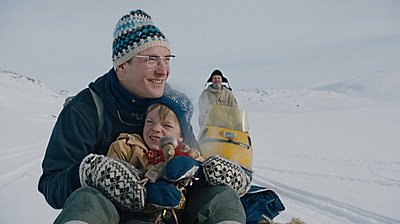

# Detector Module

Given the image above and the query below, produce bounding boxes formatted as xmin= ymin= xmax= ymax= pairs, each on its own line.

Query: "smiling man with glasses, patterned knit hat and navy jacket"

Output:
xmin=38 ymin=10 xmax=245 ymax=223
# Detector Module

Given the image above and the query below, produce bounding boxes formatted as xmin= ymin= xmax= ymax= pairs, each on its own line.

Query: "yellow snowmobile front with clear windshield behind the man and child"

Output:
xmin=199 ymin=105 xmax=253 ymax=172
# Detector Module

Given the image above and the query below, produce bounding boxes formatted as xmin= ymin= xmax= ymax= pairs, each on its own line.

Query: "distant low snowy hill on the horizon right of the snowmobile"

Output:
xmin=234 ymin=71 xmax=400 ymax=113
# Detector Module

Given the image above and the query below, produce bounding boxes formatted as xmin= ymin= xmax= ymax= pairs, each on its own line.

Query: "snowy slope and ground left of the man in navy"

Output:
xmin=0 ymin=71 xmax=64 ymax=223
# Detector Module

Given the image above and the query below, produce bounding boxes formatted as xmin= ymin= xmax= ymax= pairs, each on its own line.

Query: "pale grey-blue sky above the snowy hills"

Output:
xmin=0 ymin=0 xmax=400 ymax=100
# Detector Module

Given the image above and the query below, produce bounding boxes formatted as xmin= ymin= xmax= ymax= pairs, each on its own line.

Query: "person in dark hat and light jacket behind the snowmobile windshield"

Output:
xmin=198 ymin=69 xmax=238 ymax=127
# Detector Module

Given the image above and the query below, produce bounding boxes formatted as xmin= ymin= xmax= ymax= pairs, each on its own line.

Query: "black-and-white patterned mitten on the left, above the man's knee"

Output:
xmin=79 ymin=154 xmax=146 ymax=212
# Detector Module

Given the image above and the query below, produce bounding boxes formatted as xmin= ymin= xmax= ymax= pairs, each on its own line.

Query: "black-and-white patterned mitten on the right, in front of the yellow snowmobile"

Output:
xmin=203 ymin=156 xmax=251 ymax=197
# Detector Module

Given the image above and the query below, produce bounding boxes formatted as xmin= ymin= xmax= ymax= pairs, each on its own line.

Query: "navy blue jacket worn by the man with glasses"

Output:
xmin=38 ymin=69 xmax=198 ymax=209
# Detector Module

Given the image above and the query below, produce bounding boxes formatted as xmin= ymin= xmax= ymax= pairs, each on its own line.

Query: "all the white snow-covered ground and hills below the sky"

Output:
xmin=0 ymin=71 xmax=400 ymax=224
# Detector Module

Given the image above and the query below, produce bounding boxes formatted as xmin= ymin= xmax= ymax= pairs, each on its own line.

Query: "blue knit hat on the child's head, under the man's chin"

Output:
xmin=149 ymin=89 xmax=193 ymax=138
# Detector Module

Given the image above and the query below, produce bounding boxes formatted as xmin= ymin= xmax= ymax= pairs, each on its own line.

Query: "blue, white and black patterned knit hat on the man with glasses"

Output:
xmin=112 ymin=10 xmax=170 ymax=68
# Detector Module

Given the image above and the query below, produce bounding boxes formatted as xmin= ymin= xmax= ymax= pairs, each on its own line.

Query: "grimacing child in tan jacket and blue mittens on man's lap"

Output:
xmin=107 ymin=89 xmax=204 ymax=222
